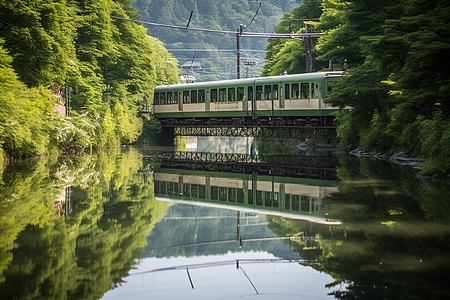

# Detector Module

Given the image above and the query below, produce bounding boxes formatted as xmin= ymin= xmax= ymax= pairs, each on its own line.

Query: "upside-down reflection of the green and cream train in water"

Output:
xmin=154 ymin=169 xmax=340 ymax=225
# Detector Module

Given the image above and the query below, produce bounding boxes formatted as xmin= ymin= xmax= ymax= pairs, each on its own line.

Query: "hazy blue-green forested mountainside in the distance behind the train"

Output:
xmin=132 ymin=0 xmax=301 ymax=81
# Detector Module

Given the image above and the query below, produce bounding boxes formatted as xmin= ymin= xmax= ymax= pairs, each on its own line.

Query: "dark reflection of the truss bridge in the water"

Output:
xmin=156 ymin=152 xmax=336 ymax=180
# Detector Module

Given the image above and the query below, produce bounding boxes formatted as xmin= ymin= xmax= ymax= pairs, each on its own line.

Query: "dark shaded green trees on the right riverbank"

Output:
xmin=263 ymin=0 xmax=450 ymax=178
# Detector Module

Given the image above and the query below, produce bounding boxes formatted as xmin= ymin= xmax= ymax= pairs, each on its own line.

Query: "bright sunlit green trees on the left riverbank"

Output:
xmin=0 ymin=0 xmax=178 ymax=169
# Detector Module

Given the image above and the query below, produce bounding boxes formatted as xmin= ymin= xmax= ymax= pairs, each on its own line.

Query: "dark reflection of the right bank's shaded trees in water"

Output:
xmin=271 ymin=160 xmax=450 ymax=299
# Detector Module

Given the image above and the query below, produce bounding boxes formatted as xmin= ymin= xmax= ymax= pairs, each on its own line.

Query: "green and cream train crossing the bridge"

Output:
xmin=153 ymin=71 xmax=342 ymax=125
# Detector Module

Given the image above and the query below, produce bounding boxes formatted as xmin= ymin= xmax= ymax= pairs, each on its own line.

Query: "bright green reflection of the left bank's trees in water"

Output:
xmin=0 ymin=149 xmax=167 ymax=299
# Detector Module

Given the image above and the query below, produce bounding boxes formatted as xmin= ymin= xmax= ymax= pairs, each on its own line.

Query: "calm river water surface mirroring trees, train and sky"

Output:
xmin=0 ymin=138 xmax=450 ymax=299
